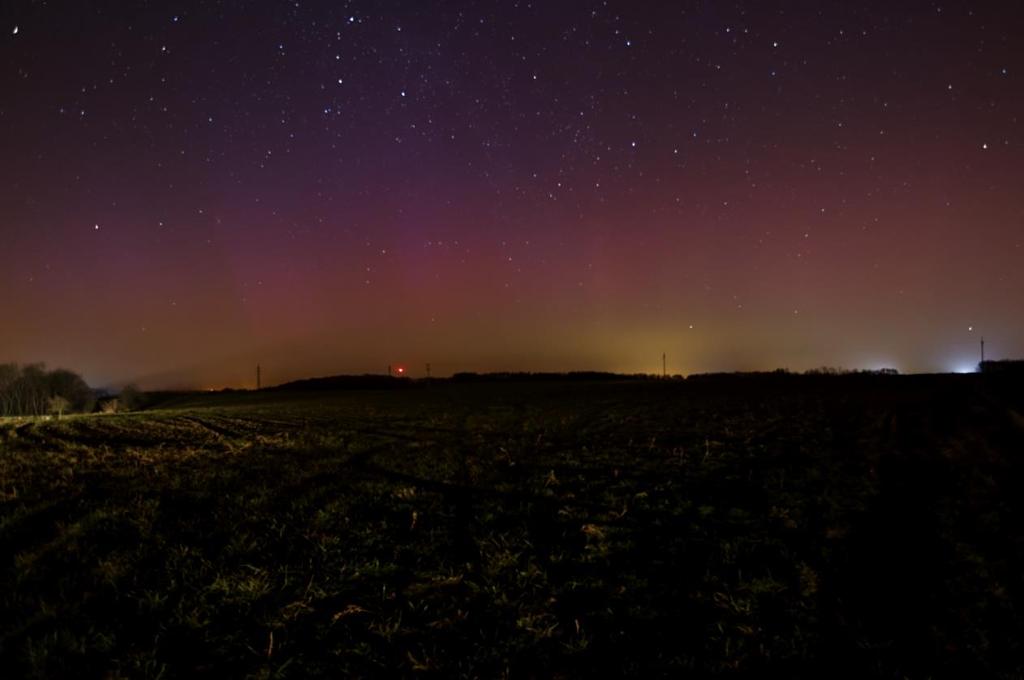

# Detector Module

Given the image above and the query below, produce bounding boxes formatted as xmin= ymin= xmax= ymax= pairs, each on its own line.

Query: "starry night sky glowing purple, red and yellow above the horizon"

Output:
xmin=0 ymin=0 xmax=1024 ymax=388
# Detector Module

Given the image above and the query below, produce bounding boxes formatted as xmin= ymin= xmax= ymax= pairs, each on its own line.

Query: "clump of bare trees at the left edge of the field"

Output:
xmin=0 ymin=364 xmax=96 ymax=417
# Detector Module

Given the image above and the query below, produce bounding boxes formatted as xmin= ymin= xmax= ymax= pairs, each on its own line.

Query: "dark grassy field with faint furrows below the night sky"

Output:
xmin=0 ymin=376 xmax=1024 ymax=678
